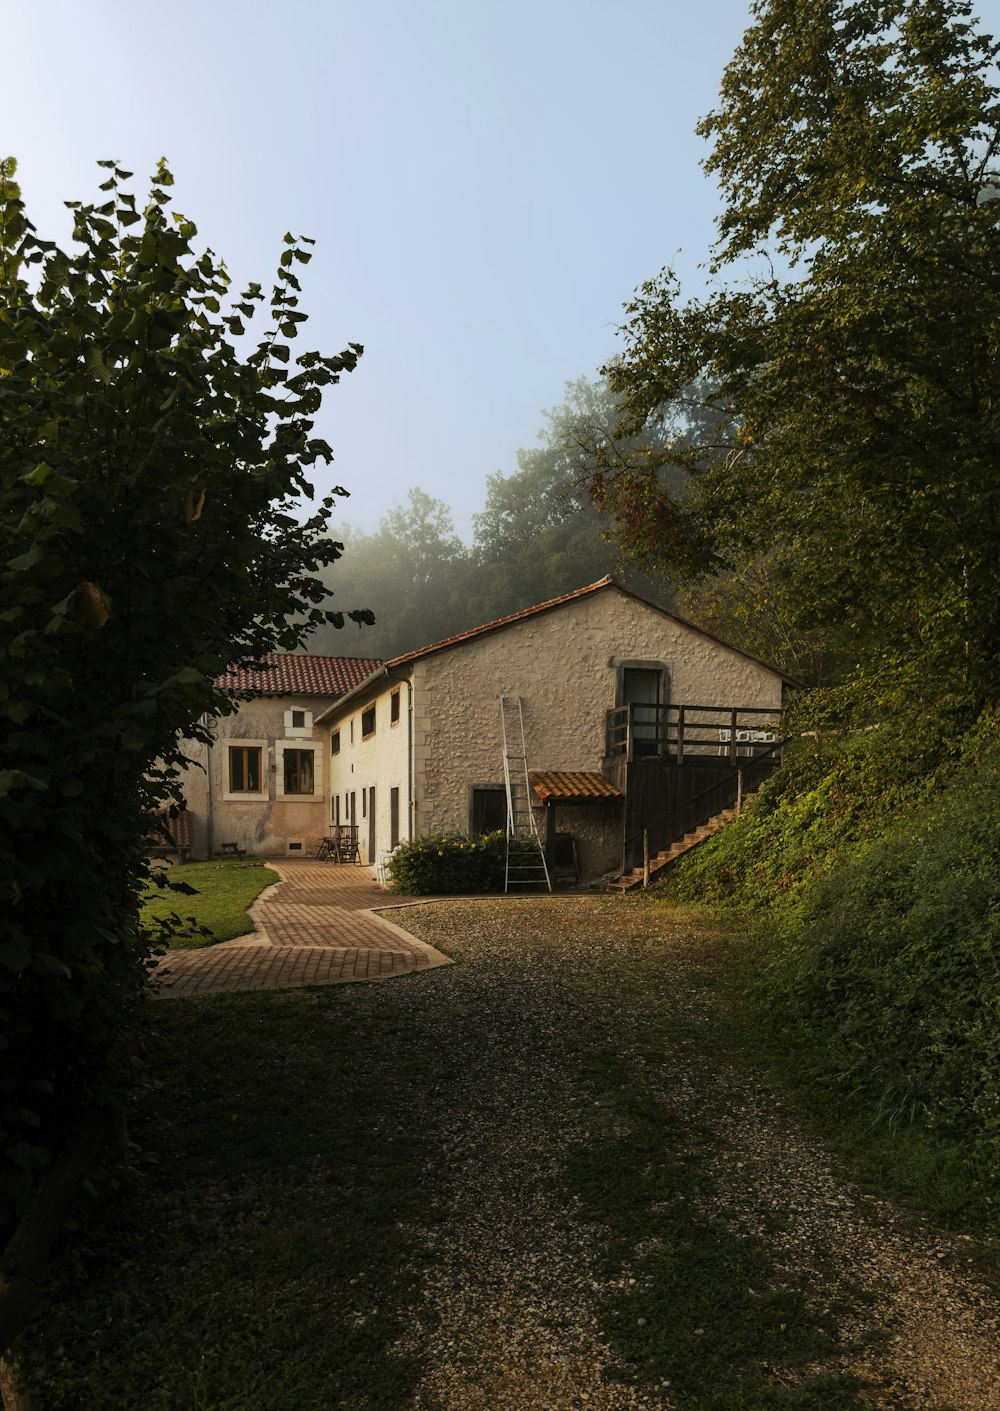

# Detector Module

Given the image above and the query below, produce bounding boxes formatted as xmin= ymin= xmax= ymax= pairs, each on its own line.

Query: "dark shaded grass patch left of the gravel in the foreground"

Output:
xmin=27 ymin=989 xmax=433 ymax=1411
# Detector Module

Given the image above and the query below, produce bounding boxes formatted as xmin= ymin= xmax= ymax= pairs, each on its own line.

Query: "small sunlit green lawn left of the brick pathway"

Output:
xmin=142 ymin=858 xmax=279 ymax=950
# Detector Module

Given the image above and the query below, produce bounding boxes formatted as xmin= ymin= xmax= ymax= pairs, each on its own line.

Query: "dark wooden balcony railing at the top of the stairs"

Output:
xmin=604 ymin=706 xmax=781 ymax=763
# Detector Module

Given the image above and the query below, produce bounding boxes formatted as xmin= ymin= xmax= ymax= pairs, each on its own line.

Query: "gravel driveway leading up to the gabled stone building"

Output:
xmin=350 ymin=897 xmax=1000 ymax=1411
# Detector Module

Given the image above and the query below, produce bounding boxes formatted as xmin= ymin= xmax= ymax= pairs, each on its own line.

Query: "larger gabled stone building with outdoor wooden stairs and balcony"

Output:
xmin=312 ymin=577 xmax=787 ymax=878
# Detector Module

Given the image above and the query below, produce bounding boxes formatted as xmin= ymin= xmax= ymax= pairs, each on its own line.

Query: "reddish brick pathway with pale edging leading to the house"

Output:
xmin=151 ymin=861 xmax=450 ymax=999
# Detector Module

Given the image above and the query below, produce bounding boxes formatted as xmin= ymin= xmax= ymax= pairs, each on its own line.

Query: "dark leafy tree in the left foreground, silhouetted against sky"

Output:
xmin=0 ymin=154 xmax=370 ymax=1348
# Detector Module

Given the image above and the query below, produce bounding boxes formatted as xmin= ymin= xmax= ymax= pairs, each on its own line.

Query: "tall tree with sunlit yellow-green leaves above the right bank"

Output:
xmin=608 ymin=0 xmax=1000 ymax=704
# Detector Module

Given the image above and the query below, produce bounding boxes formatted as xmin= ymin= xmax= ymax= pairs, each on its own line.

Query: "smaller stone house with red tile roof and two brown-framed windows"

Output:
xmin=175 ymin=652 xmax=382 ymax=858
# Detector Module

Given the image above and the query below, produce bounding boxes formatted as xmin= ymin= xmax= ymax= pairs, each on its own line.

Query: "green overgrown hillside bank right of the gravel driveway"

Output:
xmin=671 ymin=713 xmax=1000 ymax=1228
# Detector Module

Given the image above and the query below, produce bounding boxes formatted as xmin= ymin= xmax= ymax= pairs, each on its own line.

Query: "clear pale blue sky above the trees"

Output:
xmin=0 ymin=0 xmax=789 ymax=536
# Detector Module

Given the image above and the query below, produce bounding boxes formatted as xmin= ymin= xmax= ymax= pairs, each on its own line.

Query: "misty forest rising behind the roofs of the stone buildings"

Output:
xmin=309 ymin=377 xmax=842 ymax=682
